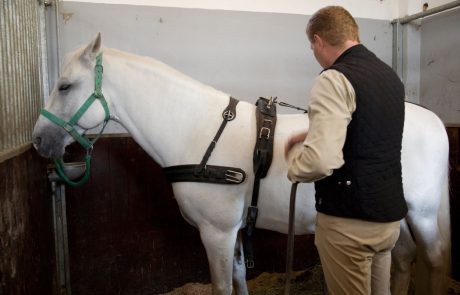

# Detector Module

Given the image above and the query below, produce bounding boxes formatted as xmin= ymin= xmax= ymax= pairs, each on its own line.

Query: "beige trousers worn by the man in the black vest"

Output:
xmin=315 ymin=212 xmax=399 ymax=295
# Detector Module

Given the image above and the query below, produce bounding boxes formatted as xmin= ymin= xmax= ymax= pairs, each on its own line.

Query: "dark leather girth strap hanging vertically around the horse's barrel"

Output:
xmin=243 ymin=97 xmax=276 ymax=268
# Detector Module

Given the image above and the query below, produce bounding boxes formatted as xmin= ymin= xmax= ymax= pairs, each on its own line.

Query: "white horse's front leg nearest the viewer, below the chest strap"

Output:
xmin=200 ymin=224 xmax=238 ymax=295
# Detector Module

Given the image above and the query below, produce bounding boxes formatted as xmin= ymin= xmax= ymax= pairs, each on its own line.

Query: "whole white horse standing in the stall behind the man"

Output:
xmin=33 ymin=35 xmax=450 ymax=295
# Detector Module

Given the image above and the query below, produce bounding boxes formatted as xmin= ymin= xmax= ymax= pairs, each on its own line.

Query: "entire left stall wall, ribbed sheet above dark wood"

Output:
xmin=0 ymin=0 xmax=55 ymax=295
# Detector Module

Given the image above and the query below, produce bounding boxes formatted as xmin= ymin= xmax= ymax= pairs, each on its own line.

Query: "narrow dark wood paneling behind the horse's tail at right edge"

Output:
xmin=447 ymin=126 xmax=460 ymax=281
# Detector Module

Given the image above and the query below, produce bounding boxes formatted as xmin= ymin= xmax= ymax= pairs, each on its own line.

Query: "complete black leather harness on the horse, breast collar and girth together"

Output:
xmin=163 ymin=97 xmax=276 ymax=268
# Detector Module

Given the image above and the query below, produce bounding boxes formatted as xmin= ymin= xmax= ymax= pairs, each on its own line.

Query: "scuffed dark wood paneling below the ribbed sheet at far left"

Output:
xmin=0 ymin=149 xmax=55 ymax=295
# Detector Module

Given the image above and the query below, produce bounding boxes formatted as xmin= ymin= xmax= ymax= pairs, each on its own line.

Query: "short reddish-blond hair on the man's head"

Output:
xmin=307 ymin=6 xmax=359 ymax=46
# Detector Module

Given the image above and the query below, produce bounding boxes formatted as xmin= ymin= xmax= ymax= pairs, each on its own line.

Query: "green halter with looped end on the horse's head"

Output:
xmin=41 ymin=53 xmax=110 ymax=186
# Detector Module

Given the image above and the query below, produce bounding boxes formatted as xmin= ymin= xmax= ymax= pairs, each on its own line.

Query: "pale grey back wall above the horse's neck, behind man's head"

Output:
xmin=50 ymin=0 xmax=392 ymax=132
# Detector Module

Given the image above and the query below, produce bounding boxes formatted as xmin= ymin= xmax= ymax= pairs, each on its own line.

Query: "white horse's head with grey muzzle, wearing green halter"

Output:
xmin=32 ymin=34 xmax=108 ymax=159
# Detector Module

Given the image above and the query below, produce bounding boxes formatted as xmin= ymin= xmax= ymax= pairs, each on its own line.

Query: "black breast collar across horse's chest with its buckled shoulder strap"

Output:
xmin=163 ymin=97 xmax=246 ymax=184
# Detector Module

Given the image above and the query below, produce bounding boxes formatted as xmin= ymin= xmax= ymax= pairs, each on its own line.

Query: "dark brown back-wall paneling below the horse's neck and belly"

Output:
xmin=66 ymin=137 xmax=318 ymax=295
